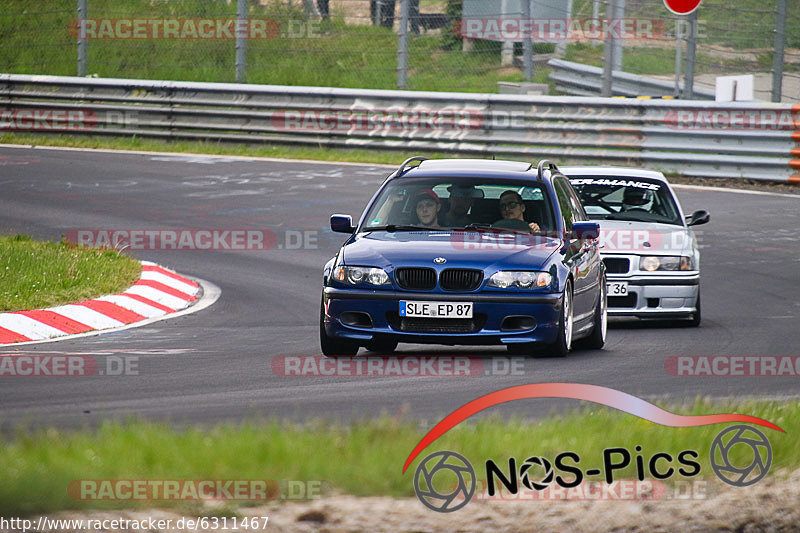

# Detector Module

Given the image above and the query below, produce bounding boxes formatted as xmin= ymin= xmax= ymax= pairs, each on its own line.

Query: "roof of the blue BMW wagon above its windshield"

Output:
xmin=400 ymin=159 xmax=538 ymax=181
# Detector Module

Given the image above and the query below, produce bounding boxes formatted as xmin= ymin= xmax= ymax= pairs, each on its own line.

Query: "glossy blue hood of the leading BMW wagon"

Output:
xmin=342 ymin=230 xmax=561 ymax=270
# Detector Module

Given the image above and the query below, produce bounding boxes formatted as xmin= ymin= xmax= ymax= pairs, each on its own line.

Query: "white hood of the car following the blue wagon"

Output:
xmin=595 ymin=220 xmax=694 ymax=255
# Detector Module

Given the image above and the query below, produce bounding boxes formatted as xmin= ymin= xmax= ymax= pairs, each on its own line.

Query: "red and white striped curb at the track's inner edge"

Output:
xmin=0 ymin=261 xmax=219 ymax=346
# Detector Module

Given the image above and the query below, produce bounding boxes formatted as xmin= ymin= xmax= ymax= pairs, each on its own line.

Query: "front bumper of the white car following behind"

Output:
xmin=607 ymin=272 xmax=700 ymax=318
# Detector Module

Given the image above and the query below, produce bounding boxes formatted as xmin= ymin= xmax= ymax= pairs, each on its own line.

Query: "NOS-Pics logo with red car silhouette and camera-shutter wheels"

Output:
xmin=403 ymin=383 xmax=783 ymax=513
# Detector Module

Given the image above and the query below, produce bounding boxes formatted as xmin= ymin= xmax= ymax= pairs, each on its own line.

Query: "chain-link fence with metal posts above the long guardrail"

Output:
xmin=0 ymin=0 xmax=800 ymax=102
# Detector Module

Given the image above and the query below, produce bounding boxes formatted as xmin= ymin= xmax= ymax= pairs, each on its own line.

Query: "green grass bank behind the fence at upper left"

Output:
xmin=0 ymin=0 xmax=542 ymax=92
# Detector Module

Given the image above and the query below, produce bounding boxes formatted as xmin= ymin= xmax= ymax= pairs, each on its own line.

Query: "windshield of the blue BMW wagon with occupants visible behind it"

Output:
xmin=362 ymin=177 xmax=555 ymax=232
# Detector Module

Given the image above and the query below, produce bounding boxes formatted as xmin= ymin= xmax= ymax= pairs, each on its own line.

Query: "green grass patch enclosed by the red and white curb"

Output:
xmin=0 ymin=235 xmax=141 ymax=311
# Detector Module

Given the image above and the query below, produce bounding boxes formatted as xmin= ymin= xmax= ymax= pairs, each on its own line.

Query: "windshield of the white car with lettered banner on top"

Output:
xmin=570 ymin=176 xmax=683 ymax=226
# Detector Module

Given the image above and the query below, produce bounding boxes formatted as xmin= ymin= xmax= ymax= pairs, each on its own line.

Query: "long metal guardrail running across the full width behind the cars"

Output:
xmin=0 ymin=74 xmax=800 ymax=182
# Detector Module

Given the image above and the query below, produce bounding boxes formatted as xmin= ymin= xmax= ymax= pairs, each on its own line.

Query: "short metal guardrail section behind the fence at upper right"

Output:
xmin=547 ymin=59 xmax=715 ymax=100
